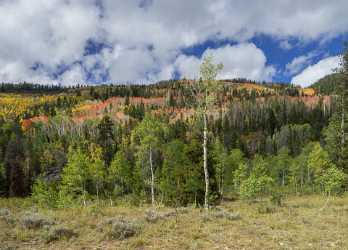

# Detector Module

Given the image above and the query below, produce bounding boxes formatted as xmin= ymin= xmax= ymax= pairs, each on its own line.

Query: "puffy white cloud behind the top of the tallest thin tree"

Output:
xmin=175 ymin=43 xmax=275 ymax=81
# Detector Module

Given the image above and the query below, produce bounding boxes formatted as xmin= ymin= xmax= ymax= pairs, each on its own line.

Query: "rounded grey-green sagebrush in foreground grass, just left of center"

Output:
xmin=107 ymin=218 xmax=141 ymax=240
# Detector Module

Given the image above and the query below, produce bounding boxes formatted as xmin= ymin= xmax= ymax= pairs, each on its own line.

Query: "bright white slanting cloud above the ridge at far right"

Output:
xmin=291 ymin=56 xmax=340 ymax=87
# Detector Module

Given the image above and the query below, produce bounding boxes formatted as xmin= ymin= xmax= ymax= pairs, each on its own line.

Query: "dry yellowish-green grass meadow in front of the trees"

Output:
xmin=0 ymin=196 xmax=348 ymax=250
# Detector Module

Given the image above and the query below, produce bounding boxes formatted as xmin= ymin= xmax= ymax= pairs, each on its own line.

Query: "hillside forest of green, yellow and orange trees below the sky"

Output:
xmin=0 ymin=47 xmax=348 ymax=250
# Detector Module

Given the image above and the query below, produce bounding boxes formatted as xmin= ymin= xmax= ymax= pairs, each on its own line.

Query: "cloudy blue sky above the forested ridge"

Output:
xmin=0 ymin=0 xmax=348 ymax=87
